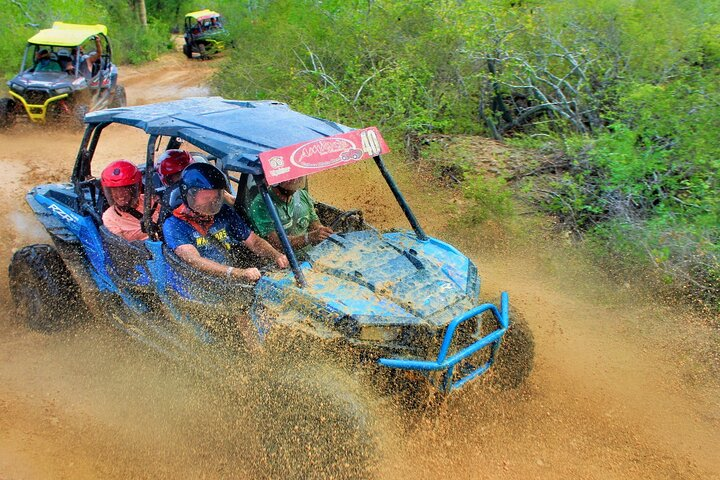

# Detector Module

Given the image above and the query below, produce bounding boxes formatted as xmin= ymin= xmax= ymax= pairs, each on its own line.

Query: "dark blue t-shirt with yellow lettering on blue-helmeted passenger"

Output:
xmin=163 ymin=205 xmax=250 ymax=264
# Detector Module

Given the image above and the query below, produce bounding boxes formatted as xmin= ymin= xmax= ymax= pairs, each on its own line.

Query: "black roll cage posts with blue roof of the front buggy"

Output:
xmin=79 ymin=97 xmax=428 ymax=287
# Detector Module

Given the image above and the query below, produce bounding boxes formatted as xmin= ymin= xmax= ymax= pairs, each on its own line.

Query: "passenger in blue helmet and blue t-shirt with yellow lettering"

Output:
xmin=163 ymin=162 xmax=289 ymax=282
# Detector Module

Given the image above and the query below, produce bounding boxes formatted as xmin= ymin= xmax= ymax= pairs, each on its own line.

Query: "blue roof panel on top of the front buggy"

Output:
xmin=85 ymin=97 xmax=353 ymax=174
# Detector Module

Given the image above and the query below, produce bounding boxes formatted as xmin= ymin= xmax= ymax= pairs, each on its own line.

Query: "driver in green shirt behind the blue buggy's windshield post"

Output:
xmin=250 ymin=177 xmax=334 ymax=249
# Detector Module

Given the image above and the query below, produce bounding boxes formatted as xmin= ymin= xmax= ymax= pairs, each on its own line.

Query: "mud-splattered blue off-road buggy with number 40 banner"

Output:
xmin=9 ymin=97 xmax=534 ymax=474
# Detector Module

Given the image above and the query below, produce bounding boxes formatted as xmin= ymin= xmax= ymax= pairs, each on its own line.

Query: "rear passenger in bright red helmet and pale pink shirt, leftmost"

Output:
xmin=100 ymin=160 xmax=158 ymax=241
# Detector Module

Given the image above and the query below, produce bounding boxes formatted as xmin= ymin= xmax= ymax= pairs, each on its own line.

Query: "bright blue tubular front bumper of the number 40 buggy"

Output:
xmin=378 ymin=292 xmax=509 ymax=393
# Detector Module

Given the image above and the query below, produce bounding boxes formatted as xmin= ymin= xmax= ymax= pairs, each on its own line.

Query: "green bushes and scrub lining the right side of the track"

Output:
xmin=214 ymin=0 xmax=720 ymax=304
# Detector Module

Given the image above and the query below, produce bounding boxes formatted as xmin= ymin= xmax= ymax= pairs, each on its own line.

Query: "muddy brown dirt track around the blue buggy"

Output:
xmin=0 ymin=54 xmax=720 ymax=480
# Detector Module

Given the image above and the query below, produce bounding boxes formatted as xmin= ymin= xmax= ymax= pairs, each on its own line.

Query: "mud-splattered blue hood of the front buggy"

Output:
xmin=296 ymin=231 xmax=479 ymax=326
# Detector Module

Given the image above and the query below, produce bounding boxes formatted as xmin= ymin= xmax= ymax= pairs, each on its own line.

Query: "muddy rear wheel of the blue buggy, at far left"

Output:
xmin=8 ymin=244 xmax=85 ymax=332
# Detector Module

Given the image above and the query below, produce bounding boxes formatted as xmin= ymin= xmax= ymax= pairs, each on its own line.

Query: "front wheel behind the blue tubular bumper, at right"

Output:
xmin=489 ymin=309 xmax=535 ymax=390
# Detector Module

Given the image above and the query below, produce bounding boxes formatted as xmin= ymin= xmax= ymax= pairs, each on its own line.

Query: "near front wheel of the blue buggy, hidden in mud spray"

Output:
xmin=252 ymin=361 xmax=378 ymax=479
